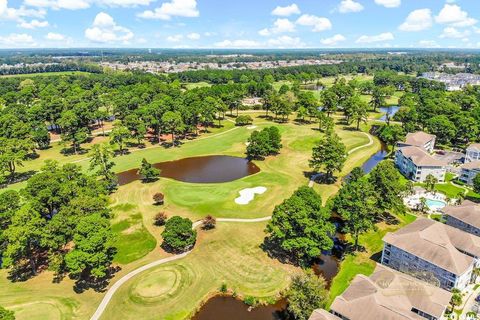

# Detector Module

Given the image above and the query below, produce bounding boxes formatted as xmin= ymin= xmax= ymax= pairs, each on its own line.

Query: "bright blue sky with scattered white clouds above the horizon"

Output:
xmin=0 ymin=0 xmax=480 ymax=48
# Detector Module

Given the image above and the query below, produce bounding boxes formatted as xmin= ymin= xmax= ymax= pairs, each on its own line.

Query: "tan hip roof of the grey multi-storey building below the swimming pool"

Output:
xmin=383 ymin=218 xmax=480 ymax=275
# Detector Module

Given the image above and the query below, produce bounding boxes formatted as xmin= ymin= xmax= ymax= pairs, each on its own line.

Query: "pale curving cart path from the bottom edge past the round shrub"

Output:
xmin=90 ymin=216 xmax=271 ymax=320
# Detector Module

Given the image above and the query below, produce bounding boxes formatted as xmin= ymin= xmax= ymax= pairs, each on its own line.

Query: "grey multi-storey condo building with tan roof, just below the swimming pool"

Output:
xmin=381 ymin=218 xmax=480 ymax=290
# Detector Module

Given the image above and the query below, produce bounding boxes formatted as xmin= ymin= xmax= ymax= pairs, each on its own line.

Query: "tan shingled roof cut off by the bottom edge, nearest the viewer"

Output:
xmin=331 ymin=264 xmax=452 ymax=320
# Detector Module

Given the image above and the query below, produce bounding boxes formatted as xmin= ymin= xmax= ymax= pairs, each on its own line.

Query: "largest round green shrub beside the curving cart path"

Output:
xmin=162 ymin=216 xmax=197 ymax=253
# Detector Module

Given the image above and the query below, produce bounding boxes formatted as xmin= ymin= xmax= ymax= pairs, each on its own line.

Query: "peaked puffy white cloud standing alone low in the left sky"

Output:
xmin=85 ymin=12 xmax=133 ymax=43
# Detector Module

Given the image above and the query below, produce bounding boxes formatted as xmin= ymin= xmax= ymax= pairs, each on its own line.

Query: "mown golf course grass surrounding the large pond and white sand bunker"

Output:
xmin=0 ymin=112 xmax=380 ymax=320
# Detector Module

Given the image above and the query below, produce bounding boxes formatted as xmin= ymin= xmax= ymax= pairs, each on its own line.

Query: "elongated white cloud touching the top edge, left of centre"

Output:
xmin=138 ymin=0 xmax=200 ymax=20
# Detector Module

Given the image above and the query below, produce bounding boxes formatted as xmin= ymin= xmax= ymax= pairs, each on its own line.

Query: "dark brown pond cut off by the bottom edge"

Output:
xmin=192 ymin=296 xmax=287 ymax=320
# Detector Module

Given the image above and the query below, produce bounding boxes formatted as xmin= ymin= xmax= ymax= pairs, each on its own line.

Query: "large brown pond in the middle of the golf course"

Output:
xmin=118 ymin=155 xmax=260 ymax=185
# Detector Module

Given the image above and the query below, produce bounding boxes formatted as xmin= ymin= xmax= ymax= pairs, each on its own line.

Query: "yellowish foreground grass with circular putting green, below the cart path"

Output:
xmin=102 ymin=222 xmax=296 ymax=320
